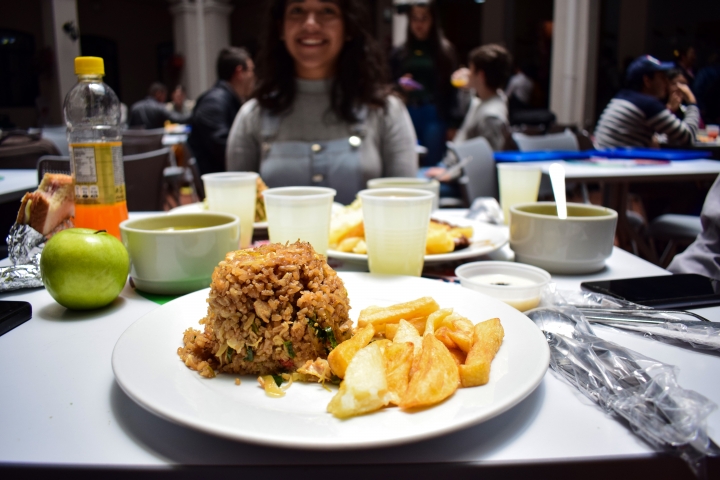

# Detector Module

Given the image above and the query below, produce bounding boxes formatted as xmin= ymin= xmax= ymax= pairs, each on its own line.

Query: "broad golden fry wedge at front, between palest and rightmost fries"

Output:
xmin=400 ymin=335 xmax=460 ymax=409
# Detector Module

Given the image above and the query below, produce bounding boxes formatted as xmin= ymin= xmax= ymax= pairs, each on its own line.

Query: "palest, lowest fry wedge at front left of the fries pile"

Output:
xmin=327 ymin=342 xmax=391 ymax=418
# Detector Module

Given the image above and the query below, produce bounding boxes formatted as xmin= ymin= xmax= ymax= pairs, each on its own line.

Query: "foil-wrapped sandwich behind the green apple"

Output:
xmin=0 ymin=174 xmax=75 ymax=292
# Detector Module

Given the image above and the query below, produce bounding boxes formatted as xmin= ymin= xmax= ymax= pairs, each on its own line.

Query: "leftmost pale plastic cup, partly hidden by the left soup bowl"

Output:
xmin=200 ymin=172 xmax=258 ymax=248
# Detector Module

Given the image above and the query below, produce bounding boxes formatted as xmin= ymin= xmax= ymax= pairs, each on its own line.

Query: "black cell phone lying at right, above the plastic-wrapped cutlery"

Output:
xmin=580 ymin=273 xmax=720 ymax=310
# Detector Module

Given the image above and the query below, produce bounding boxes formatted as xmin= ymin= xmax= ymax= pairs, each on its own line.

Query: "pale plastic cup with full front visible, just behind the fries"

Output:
xmin=358 ymin=188 xmax=433 ymax=277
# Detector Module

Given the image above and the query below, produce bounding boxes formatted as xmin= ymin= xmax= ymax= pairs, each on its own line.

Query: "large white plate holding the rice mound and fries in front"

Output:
xmin=112 ymin=272 xmax=550 ymax=450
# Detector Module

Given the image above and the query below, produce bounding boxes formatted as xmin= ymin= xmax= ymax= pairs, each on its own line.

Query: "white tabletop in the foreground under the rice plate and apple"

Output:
xmin=0 ymin=219 xmax=720 ymax=471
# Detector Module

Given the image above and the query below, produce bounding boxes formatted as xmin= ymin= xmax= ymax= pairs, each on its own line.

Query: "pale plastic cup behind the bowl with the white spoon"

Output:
xmin=497 ymin=163 xmax=542 ymax=225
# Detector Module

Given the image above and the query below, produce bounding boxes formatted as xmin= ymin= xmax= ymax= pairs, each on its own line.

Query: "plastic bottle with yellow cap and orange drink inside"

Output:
xmin=63 ymin=57 xmax=128 ymax=238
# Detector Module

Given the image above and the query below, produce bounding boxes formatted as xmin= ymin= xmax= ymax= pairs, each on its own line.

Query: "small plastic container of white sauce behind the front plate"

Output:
xmin=455 ymin=262 xmax=550 ymax=312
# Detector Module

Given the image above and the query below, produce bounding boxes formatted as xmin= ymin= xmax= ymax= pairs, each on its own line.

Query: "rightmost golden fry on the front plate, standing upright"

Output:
xmin=459 ymin=318 xmax=505 ymax=387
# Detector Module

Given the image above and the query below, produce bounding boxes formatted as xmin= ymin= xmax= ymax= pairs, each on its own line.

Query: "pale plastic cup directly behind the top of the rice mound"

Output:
xmin=263 ymin=187 xmax=337 ymax=255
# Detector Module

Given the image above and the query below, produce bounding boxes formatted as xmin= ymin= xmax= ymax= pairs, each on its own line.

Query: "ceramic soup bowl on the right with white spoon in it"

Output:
xmin=510 ymin=202 xmax=617 ymax=274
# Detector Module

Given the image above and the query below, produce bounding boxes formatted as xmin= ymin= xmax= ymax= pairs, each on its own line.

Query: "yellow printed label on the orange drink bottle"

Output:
xmin=70 ymin=142 xmax=125 ymax=205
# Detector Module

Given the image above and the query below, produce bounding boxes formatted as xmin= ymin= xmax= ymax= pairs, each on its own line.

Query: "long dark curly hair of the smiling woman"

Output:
xmin=253 ymin=0 xmax=388 ymax=123
